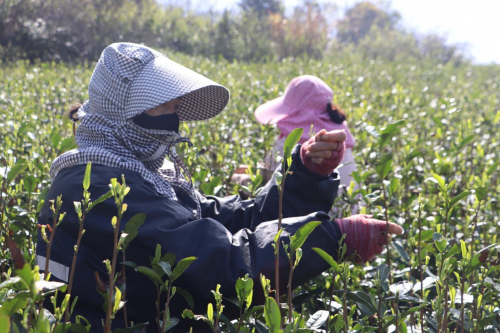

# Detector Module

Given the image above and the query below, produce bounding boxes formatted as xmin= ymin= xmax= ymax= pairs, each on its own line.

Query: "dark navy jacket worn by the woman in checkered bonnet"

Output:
xmin=37 ymin=146 xmax=341 ymax=332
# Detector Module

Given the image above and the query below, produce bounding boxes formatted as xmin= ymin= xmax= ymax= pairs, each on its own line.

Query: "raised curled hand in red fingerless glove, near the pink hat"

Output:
xmin=300 ymin=130 xmax=347 ymax=176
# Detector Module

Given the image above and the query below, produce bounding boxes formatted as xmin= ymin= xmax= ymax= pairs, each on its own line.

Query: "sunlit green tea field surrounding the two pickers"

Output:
xmin=0 ymin=54 xmax=500 ymax=333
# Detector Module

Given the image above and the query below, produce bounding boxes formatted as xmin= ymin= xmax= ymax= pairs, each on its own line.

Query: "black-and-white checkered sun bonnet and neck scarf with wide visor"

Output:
xmin=50 ymin=43 xmax=229 ymax=217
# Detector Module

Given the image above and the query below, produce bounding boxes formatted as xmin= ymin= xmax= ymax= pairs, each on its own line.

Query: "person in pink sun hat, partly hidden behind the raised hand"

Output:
xmin=255 ymin=75 xmax=356 ymax=186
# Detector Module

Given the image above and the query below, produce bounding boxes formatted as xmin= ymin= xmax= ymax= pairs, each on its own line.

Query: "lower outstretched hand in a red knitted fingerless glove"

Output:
xmin=335 ymin=214 xmax=403 ymax=263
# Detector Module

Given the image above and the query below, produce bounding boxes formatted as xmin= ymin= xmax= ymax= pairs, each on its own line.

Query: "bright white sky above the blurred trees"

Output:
xmin=169 ymin=0 xmax=500 ymax=64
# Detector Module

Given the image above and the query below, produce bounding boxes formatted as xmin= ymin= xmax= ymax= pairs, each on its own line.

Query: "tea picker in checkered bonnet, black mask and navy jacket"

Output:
xmin=37 ymin=43 xmax=406 ymax=332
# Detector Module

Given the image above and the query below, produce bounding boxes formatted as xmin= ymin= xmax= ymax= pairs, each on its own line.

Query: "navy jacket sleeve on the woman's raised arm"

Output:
xmin=200 ymin=145 xmax=340 ymax=233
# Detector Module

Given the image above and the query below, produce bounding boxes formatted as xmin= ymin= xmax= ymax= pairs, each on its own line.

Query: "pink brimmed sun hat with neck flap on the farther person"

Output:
xmin=255 ymin=75 xmax=356 ymax=148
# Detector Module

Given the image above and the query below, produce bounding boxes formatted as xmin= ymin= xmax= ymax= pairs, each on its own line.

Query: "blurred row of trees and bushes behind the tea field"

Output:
xmin=0 ymin=0 xmax=464 ymax=63
